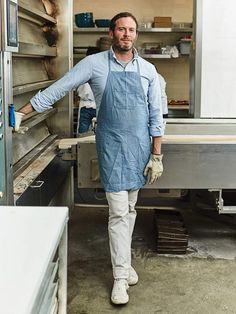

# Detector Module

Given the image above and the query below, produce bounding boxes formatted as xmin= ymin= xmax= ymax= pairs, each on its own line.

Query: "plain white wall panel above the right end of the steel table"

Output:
xmin=200 ymin=0 xmax=236 ymax=118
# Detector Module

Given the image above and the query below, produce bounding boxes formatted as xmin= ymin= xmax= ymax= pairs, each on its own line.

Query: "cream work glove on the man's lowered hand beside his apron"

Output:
xmin=144 ymin=154 xmax=163 ymax=184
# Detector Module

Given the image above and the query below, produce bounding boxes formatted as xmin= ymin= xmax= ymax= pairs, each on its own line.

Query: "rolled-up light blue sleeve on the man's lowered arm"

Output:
xmin=147 ymin=71 xmax=165 ymax=137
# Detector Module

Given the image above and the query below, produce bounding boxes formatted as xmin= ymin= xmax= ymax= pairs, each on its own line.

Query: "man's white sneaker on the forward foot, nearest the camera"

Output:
xmin=111 ymin=279 xmax=129 ymax=304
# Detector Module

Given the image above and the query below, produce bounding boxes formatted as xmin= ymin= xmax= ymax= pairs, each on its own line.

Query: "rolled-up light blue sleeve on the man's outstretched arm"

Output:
xmin=30 ymin=56 xmax=92 ymax=112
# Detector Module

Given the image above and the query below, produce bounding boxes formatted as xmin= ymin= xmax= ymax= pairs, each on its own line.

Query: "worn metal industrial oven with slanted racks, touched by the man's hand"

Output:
xmin=0 ymin=0 xmax=73 ymax=206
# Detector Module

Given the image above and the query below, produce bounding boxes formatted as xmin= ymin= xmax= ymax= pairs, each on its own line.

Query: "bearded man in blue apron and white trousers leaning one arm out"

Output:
xmin=16 ymin=12 xmax=164 ymax=304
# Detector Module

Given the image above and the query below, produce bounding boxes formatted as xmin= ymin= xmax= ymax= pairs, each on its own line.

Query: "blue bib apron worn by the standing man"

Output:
xmin=96 ymin=53 xmax=151 ymax=192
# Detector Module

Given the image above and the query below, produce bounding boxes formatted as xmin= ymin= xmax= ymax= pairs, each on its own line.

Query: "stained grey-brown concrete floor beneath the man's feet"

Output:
xmin=68 ymin=200 xmax=236 ymax=314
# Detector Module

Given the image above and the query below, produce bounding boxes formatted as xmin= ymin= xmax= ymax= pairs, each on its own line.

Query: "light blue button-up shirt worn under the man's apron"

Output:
xmin=30 ymin=48 xmax=164 ymax=136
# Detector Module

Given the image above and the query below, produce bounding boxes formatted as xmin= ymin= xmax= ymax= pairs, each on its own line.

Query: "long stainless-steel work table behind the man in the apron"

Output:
xmin=59 ymin=132 xmax=236 ymax=189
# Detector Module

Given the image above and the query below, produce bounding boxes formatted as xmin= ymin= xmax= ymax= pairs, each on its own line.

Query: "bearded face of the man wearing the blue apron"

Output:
xmin=109 ymin=17 xmax=137 ymax=51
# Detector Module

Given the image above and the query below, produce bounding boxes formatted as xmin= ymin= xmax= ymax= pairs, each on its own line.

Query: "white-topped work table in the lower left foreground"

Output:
xmin=0 ymin=206 xmax=68 ymax=314
